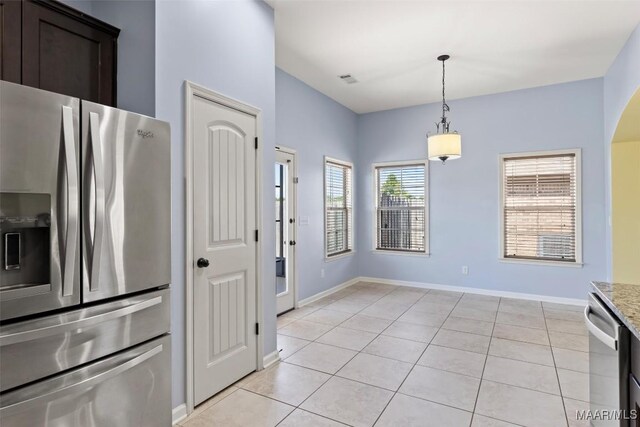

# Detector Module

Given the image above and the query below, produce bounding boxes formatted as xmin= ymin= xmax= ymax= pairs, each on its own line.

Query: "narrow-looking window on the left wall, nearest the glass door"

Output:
xmin=324 ymin=158 xmax=353 ymax=257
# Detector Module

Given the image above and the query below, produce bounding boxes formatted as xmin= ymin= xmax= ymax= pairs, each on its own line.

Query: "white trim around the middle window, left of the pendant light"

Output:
xmin=371 ymin=159 xmax=431 ymax=257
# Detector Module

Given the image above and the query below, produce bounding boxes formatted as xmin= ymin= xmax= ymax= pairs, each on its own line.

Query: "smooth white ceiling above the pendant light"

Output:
xmin=267 ymin=0 xmax=640 ymax=113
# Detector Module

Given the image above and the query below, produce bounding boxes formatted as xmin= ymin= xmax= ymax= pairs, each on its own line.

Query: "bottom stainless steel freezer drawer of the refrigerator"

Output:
xmin=0 ymin=335 xmax=171 ymax=427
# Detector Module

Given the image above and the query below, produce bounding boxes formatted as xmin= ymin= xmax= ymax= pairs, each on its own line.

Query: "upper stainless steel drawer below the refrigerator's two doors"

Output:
xmin=0 ymin=289 xmax=171 ymax=392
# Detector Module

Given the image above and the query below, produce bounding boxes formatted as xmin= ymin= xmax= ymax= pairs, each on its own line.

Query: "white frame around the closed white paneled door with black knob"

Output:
xmin=184 ymin=80 xmax=264 ymax=414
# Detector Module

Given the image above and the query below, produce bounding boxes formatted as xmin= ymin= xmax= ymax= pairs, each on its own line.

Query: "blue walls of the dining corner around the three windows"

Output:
xmin=276 ymin=69 xmax=607 ymax=299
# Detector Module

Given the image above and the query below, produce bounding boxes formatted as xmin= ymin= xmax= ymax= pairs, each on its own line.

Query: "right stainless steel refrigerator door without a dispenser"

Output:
xmin=82 ymin=101 xmax=171 ymax=301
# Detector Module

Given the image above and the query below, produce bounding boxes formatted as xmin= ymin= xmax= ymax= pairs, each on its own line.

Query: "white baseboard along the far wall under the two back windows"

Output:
xmin=356 ymin=277 xmax=587 ymax=306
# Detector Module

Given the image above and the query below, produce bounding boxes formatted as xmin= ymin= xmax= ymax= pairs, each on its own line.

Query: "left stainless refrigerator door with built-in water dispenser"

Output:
xmin=0 ymin=81 xmax=80 ymax=320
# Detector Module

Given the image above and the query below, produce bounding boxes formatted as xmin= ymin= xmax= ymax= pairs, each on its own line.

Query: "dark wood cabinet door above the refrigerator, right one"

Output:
xmin=22 ymin=1 xmax=116 ymax=105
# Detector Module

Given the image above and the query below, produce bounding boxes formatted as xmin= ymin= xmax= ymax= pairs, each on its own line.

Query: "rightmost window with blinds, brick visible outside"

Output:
xmin=501 ymin=150 xmax=582 ymax=263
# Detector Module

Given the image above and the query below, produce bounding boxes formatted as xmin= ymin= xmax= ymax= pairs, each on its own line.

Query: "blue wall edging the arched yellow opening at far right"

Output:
xmin=604 ymin=26 xmax=640 ymax=279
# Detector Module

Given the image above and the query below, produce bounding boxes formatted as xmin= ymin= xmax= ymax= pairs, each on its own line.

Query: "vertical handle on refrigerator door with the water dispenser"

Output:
xmin=62 ymin=106 xmax=78 ymax=296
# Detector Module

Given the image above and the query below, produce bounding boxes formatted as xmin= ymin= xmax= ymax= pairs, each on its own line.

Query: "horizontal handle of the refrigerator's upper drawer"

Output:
xmin=0 ymin=296 xmax=162 ymax=347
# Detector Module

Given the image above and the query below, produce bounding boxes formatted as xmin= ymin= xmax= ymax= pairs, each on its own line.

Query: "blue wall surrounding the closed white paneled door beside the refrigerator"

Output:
xmin=156 ymin=1 xmax=276 ymax=407
